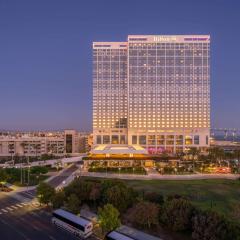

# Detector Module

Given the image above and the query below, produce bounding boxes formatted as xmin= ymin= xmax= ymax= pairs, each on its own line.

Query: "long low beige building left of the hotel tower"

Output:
xmin=0 ymin=130 xmax=90 ymax=157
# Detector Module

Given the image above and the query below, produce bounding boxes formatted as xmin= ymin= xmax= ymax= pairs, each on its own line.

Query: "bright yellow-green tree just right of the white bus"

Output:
xmin=98 ymin=204 xmax=120 ymax=233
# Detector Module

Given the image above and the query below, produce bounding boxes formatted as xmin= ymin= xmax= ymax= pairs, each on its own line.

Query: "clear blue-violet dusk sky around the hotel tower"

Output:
xmin=0 ymin=0 xmax=240 ymax=130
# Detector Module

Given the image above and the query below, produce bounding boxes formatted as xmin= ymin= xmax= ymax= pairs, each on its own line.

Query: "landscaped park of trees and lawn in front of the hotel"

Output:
xmin=37 ymin=177 xmax=240 ymax=240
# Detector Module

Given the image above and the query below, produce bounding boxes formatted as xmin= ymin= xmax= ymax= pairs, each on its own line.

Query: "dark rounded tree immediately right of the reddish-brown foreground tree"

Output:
xmin=160 ymin=198 xmax=194 ymax=231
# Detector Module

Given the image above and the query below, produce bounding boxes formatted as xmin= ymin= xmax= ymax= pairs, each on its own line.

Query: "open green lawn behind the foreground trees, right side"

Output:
xmin=126 ymin=179 xmax=240 ymax=217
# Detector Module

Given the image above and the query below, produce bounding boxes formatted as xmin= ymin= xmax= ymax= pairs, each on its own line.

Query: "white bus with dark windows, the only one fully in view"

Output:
xmin=52 ymin=209 xmax=93 ymax=238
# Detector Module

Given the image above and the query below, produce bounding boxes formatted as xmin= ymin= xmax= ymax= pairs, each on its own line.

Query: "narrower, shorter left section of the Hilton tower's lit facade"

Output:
xmin=93 ymin=42 xmax=127 ymax=144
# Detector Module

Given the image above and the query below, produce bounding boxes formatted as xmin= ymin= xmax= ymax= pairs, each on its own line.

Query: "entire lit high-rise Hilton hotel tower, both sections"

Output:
xmin=93 ymin=35 xmax=210 ymax=153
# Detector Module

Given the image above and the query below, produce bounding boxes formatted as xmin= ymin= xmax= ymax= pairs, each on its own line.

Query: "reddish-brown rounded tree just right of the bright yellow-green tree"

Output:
xmin=129 ymin=201 xmax=159 ymax=228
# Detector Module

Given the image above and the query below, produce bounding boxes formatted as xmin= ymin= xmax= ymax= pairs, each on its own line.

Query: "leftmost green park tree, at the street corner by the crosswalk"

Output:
xmin=37 ymin=182 xmax=55 ymax=205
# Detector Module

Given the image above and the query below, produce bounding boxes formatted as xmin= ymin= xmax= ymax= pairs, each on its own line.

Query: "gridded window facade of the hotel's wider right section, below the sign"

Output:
xmin=128 ymin=37 xmax=210 ymax=129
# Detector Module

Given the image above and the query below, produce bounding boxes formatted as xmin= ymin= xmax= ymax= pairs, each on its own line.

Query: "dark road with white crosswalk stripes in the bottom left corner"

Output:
xmin=0 ymin=193 xmax=74 ymax=240
